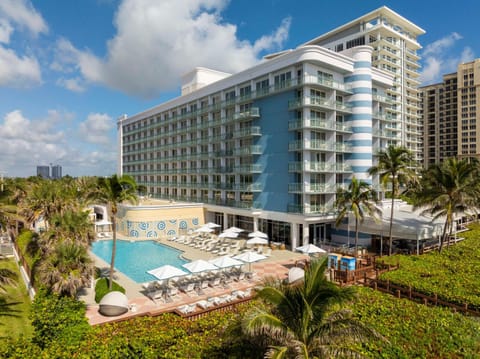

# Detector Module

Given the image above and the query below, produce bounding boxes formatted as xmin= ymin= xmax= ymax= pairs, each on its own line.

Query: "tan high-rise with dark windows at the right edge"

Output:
xmin=420 ymin=59 xmax=480 ymax=167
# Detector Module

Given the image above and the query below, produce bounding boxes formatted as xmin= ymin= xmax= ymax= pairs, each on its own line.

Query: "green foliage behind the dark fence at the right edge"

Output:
xmin=380 ymin=224 xmax=480 ymax=310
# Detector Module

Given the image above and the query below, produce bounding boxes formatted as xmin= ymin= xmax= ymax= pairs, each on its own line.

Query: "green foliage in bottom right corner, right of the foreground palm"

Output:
xmin=351 ymin=288 xmax=480 ymax=359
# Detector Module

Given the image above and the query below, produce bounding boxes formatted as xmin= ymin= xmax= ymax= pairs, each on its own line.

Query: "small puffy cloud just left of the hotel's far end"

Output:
xmin=79 ymin=113 xmax=115 ymax=145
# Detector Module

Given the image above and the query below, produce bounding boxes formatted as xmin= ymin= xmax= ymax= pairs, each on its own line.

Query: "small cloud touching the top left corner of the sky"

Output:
xmin=0 ymin=0 xmax=48 ymax=36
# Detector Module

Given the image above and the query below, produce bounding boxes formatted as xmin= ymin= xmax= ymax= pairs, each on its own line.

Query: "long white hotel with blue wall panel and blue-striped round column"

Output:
xmin=118 ymin=8 xmax=424 ymax=248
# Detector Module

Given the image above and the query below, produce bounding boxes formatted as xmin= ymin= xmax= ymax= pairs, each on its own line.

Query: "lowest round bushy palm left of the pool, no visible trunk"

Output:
xmin=35 ymin=240 xmax=92 ymax=298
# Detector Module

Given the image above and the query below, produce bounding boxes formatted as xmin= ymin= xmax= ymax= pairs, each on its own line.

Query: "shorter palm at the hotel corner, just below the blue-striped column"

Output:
xmin=335 ymin=176 xmax=381 ymax=257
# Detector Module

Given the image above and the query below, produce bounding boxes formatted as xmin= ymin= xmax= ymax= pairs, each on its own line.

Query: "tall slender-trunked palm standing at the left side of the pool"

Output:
xmin=90 ymin=175 xmax=138 ymax=290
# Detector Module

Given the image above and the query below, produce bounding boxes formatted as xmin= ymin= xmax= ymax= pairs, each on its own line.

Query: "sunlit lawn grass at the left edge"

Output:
xmin=0 ymin=258 xmax=33 ymax=341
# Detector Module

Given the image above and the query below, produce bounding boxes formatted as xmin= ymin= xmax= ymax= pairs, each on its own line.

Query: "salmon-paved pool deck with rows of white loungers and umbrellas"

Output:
xmin=79 ymin=236 xmax=309 ymax=325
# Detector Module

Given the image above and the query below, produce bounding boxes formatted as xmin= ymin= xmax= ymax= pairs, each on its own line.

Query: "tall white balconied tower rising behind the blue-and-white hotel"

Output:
xmin=306 ymin=6 xmax=425 ymax=165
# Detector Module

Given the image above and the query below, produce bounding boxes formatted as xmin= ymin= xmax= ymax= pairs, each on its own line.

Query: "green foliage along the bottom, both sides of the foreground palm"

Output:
xmin=0 ymin=288 xmax=480 ymax=359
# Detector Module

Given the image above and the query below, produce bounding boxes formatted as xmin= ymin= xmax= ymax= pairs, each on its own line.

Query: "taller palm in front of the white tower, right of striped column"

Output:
xmin=368 ymin=145 xmax=416 ymax=255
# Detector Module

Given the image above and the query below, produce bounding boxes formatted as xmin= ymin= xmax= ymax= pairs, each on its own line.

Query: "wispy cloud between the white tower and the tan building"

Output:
xmin=420 ymin=32 xmax=475 ymax=85
